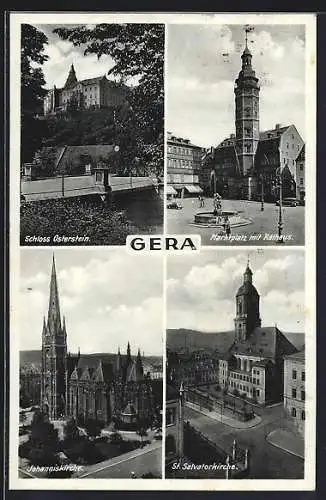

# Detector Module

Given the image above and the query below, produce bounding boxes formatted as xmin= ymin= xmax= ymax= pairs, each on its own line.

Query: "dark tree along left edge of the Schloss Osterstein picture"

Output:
xmin=21 ymin=24 xmax=48 ymax=162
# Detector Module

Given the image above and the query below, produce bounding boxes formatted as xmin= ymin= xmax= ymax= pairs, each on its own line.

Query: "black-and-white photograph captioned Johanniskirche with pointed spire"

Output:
xmin=17 ymin=249 xmax=163 ymax=479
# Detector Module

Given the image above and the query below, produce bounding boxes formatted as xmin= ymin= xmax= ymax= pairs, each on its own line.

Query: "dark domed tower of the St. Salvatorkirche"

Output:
xmin=234 ymin=261 xmax=261 ymax=342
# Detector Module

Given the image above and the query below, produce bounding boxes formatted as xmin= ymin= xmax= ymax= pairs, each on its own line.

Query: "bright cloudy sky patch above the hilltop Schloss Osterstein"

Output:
xmin=35 ymin=24 xmax=125 ymax=89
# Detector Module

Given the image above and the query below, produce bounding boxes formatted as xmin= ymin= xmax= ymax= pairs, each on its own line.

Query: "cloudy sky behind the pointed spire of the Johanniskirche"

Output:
xmin=19 ymin=247 xmax=163 ymax=356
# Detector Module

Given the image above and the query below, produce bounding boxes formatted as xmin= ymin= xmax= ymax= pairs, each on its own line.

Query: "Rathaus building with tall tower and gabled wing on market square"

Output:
xmin=201 ymin=31 xmax=304 ymax=201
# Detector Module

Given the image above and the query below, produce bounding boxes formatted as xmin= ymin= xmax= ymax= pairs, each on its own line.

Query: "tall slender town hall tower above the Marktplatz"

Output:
xmin=234 ymin=28 xmax=260 ymax=176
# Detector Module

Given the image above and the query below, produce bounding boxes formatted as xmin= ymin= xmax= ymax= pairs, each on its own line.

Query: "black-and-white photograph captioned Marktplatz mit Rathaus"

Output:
xmin=166 ymin=24 xmax=309 ymax=246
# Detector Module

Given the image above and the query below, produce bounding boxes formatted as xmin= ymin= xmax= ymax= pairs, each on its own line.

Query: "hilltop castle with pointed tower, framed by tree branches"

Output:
xmin=43 ymin=64 xmax=128 ymax=115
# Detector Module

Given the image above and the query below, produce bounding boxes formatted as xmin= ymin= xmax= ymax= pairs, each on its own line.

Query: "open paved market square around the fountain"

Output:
xmin=167 ymin=198 xmax=305 ymax=246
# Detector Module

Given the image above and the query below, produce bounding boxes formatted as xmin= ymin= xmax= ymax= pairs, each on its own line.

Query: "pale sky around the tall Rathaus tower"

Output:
xmin=167 ymin=24 xmax=305 ymax=147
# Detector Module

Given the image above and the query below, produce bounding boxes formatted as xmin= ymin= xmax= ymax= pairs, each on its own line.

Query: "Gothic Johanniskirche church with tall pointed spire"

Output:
xmin=41 ymin=256 xmax=154 ymax=427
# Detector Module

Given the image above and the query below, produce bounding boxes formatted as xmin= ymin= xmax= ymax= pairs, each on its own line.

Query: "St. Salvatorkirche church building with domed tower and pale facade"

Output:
xmin=219 ymin=262 xmax=298 ymax=405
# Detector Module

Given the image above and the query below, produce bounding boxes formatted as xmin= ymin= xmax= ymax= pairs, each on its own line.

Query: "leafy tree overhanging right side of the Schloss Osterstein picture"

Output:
xmin=54 ymin=24 xmax=164 ymax=175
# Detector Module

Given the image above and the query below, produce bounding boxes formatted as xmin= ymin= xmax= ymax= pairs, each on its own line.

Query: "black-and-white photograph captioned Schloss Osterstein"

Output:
xmin=20 ymin=24 xmax=165 ymax=246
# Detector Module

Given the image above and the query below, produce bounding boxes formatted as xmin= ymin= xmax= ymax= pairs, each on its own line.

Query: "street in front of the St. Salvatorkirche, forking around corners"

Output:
xmin=184 ymin=405 xmax=304 ymax=479
